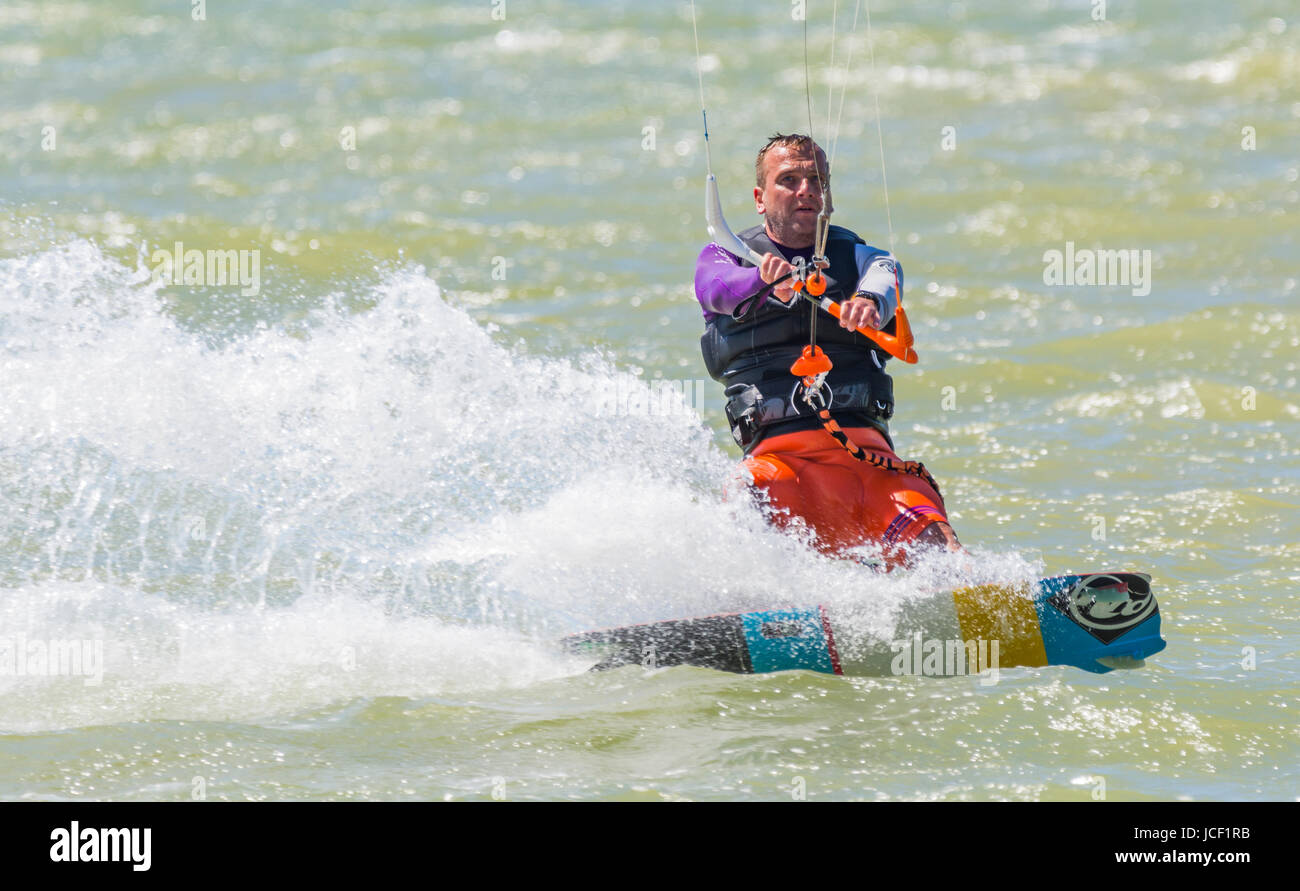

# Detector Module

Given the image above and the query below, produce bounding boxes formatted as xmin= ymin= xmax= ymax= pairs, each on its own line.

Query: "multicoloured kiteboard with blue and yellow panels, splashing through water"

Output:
xmin=560 ymin=572 xmax=1165 ymax=676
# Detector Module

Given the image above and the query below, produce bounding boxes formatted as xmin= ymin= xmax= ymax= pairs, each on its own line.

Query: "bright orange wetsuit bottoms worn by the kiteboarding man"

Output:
xmin=744 ymin=427 xmax=948 ymax=567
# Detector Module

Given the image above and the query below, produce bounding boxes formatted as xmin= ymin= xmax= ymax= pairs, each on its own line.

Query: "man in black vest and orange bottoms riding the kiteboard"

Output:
xmin=696 ymin=134 xmax=961 ymax=568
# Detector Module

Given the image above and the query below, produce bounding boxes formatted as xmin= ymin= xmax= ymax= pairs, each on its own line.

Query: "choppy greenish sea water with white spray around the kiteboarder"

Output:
xmin=0 ymin=1 xmax=1300 ymax=800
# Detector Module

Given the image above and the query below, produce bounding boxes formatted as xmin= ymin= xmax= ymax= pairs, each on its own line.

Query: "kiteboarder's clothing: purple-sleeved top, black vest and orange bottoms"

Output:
xmin=696 ymin=226 xmax=948 ymax=566
